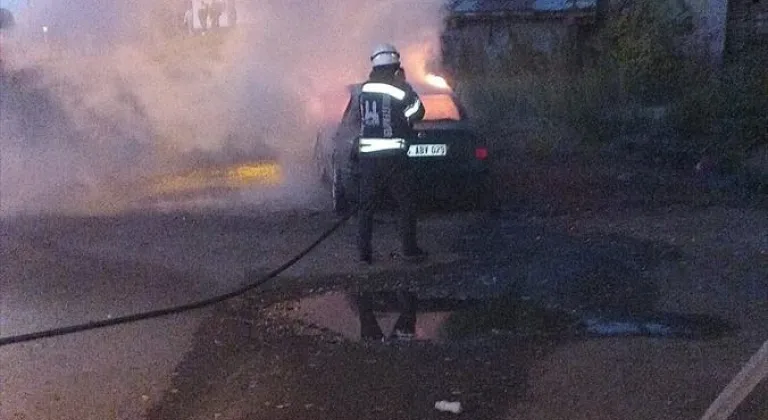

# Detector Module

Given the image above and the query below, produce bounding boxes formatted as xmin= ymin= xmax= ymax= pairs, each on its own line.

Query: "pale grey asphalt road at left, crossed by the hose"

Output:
xmin=0 ymin=168 xmax=334 ymax=420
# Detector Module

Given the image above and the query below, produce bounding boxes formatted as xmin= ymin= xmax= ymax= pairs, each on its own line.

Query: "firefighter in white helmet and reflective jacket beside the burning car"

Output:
xmin=353 ymin=44 xmax=426 ymax=264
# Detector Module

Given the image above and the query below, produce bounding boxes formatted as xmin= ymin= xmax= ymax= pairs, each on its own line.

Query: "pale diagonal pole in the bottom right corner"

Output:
xmin=701 ymin=341 xmax=768 ymax=420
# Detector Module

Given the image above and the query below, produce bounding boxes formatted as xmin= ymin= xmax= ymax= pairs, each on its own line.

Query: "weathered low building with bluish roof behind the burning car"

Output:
xmin=442 ymin=0 xmax=597 ymax=75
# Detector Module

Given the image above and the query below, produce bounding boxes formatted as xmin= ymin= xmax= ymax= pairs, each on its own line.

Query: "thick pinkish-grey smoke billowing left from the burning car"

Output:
xmin=0 ymin=0 xmax=442 ymax=215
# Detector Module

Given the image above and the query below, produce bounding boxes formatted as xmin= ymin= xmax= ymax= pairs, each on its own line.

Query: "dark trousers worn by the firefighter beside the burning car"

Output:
xmin=357 ymin=156 xmax=418 ymax=256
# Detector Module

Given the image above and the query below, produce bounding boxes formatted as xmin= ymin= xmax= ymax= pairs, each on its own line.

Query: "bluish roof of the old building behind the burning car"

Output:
xmin=451 ymin=0 xmax=597 ymax=13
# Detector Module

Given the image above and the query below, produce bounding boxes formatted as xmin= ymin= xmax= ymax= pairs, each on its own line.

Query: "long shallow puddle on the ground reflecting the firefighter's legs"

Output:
xmin=280 ymin=291 xmax=734 ymax=342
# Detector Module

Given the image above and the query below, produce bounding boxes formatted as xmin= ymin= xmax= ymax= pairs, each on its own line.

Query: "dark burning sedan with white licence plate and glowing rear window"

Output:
xmin=314 ymin=81 xmax=494 ymax=213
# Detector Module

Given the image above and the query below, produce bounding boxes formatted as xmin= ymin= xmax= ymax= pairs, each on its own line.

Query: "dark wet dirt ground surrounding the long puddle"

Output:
xmin=149 ymin=157 xmax=768 ymax=420
